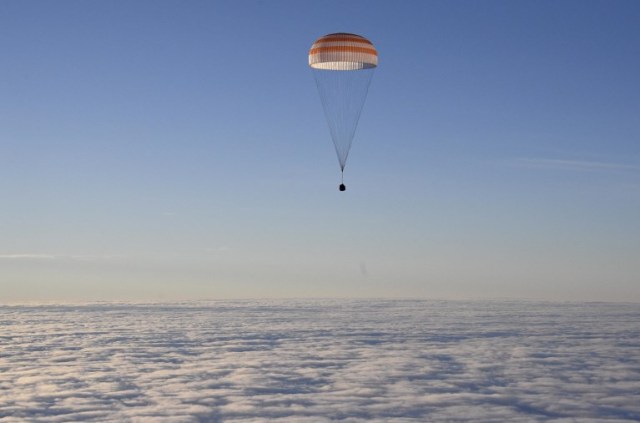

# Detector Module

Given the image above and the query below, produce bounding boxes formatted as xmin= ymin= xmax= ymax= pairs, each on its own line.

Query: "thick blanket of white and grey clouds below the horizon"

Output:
xmin=0 ymin=300 xmax=640 ymax=422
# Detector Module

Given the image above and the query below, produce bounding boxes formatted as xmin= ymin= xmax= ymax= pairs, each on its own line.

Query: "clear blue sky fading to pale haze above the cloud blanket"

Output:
xmin=0 ymin=0 xmax=640 ymax=303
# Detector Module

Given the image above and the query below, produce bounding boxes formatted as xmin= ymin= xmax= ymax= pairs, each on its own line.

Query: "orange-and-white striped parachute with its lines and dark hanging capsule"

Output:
xmin=309 ymin=32 xmax=378 ymax=191
